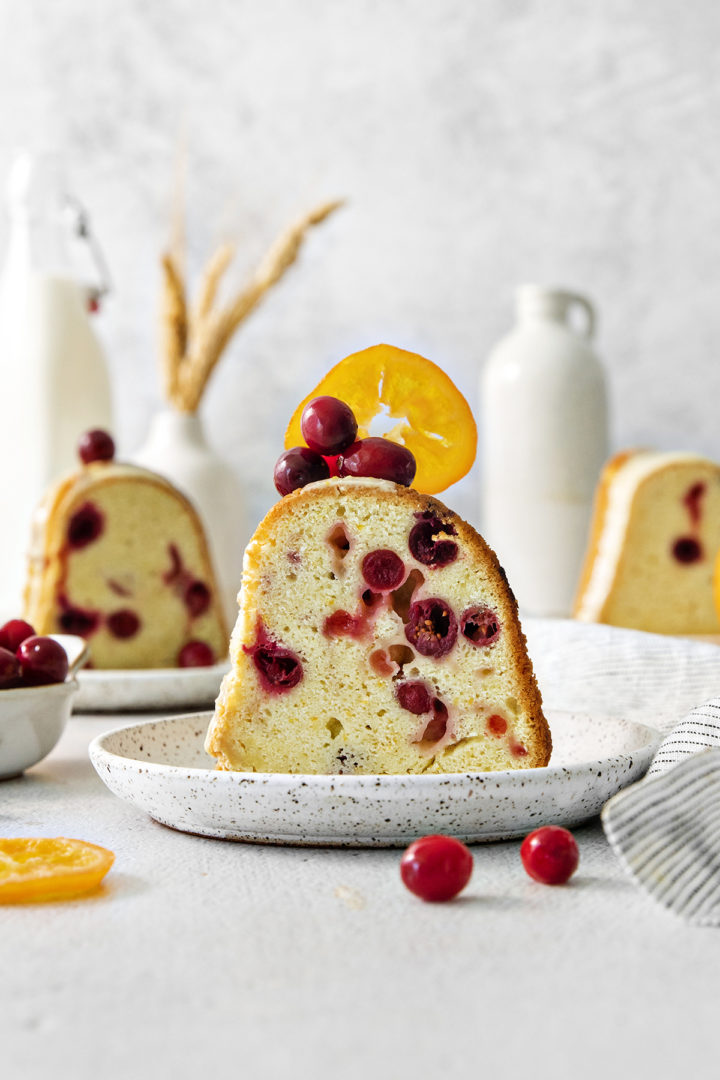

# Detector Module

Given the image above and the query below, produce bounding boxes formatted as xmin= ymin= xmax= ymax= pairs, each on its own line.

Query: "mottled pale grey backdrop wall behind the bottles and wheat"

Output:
xmin=0 ymin=0 xmax=720 ymax=518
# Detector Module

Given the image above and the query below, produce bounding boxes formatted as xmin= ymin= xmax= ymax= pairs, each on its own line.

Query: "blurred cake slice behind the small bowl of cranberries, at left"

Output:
xmin=25 ymin=453 xmax=228 ymax=667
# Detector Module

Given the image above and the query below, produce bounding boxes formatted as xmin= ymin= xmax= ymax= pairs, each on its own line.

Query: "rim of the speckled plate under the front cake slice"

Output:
xmin=87 ymin=708 xmax=663 ymax=789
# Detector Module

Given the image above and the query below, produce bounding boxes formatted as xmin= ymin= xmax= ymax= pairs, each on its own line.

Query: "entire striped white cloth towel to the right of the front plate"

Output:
xmin=522 ymin=618 xmax=720 ymax=926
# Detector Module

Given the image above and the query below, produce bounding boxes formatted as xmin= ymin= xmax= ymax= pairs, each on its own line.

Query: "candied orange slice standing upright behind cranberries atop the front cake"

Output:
xmin=285 ymin=345 xmax=477 ymax=494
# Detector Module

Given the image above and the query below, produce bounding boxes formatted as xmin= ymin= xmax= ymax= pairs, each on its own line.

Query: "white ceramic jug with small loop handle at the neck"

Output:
xmin=480 ymin=285 xmax=608 ymax=616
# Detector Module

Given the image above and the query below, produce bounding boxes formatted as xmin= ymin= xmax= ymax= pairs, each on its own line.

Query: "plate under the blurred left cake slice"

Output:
xmin=73 ymin=661 xmax=230 ymax=713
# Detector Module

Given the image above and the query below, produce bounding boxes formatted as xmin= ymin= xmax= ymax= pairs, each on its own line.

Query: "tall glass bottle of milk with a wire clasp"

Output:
xmin=0 ymin=153 xmax=112 ymax=617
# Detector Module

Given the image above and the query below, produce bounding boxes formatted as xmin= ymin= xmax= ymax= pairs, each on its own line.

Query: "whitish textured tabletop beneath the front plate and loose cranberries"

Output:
xmin=0 ymin=716 xmax=720 ymax=1080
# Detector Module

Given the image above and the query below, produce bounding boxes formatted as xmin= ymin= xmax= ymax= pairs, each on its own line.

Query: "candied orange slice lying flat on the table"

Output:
xmin=0 ymin=836 xmax=116 ymax=904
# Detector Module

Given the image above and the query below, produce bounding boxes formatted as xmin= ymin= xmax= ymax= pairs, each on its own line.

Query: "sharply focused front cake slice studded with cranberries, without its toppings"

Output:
xmin=206 ymin=478 xmax=551 ymax=773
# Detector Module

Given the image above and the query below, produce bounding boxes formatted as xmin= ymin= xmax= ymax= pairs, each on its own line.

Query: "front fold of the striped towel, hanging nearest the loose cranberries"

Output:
xmin=602 ymin=698 xmax=720 ymax=927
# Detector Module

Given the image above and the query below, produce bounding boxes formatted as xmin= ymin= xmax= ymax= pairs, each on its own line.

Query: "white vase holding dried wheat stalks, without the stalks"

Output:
xmin=133 ymin=408 xmax=248 ymax=626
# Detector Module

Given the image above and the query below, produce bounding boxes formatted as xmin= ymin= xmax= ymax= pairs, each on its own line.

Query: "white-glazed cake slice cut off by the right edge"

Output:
xmin=574 ymin=450 xmax=720 ymax=634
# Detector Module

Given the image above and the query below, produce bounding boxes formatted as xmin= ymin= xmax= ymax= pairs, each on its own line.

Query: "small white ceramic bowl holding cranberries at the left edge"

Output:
xmin=0 ymin=634 xmax=87 ymax=780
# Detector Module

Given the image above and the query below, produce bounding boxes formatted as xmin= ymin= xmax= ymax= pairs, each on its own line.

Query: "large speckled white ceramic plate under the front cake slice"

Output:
xmin=90 ymin=712 xmax=660 ymax=848
